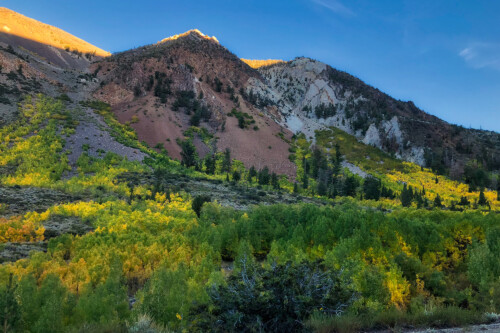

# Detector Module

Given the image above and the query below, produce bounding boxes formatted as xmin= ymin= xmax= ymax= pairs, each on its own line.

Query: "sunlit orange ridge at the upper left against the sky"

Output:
xmin=0 ymin=7 xmax=111 ymax=57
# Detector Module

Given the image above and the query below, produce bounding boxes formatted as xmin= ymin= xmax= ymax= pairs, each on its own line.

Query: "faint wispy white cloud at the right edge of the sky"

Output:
xmin=458 ymin=42 xmax=500 ymax=71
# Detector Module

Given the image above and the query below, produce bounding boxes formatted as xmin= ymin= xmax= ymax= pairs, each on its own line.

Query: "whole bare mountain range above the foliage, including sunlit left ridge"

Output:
xmin=0 ymin=9 xmax=500 ymax=186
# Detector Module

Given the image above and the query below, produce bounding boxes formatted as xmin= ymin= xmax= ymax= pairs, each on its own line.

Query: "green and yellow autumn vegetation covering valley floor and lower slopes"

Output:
xmin=0 ymin=96 xmax=500 ymax=332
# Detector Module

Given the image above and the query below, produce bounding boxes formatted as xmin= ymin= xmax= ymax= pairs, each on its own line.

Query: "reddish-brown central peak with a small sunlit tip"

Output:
xmin=92 ymin=30 xmax=295 ymax=177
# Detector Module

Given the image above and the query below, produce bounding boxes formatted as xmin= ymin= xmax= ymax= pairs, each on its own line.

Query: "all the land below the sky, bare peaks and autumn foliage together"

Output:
xmin=0 ymin=11 xmax=500 ymax=333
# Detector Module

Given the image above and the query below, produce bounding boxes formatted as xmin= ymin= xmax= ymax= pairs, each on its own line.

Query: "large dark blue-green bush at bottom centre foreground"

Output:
xmin=192 ymin=260 xmax=355 ymax=332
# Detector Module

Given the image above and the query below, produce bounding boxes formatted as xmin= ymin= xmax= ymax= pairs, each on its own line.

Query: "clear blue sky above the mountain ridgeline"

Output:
xmin=0 ymin=0 xmax=500 ymax=132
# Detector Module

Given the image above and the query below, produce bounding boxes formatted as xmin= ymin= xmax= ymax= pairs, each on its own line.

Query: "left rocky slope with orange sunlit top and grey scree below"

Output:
xmin=0 ymin=8 xmax=144 ymax=166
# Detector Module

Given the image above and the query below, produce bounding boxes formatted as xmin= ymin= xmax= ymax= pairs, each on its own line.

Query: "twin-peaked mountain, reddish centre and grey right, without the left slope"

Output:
xmin=93 ymin=30 xmax=500 ymax=179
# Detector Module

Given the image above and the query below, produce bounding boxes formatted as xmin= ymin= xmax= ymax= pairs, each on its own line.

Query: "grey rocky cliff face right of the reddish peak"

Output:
xmin=247 ymin=58 xmax=500 ymax=177
